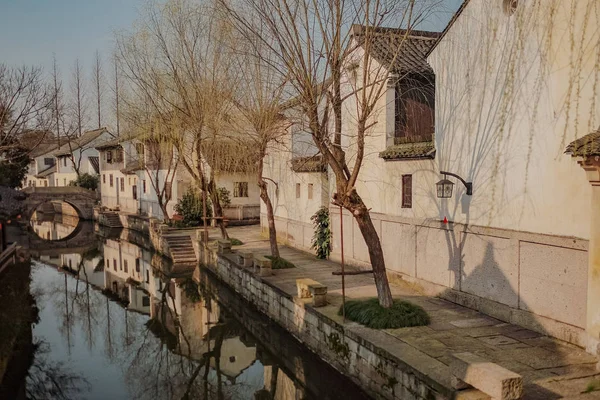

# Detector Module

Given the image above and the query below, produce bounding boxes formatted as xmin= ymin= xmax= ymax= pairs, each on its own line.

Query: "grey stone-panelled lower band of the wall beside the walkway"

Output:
xmin=330 ymin=208 xmax=588 ymax=345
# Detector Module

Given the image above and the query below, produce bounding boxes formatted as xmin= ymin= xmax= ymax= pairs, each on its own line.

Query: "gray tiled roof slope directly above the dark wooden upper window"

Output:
xmin=352 ymin=25 xmax=441 ymax=75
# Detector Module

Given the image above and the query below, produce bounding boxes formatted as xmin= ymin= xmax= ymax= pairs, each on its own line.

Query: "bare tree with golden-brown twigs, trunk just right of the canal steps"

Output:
xmin=117 ymin=0 xmax=235 ymax=237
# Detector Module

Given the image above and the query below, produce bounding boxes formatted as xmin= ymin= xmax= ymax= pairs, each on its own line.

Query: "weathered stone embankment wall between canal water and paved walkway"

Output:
xmin=206 ymin=250 xmax=455 ymax=400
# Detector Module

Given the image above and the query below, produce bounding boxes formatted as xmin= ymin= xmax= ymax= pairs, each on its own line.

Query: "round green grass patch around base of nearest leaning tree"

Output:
xmin=338 ymin=298 xmax=429 ymax=329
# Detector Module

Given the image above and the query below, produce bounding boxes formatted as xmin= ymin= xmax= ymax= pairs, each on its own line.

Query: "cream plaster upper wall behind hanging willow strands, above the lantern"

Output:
xmin=429 ymin=0 xmax=600 ymax=238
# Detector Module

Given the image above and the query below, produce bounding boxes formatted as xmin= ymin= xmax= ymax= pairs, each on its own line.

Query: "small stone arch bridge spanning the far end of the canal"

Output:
xmin=22 ymin=186 xmax=98 ymax=220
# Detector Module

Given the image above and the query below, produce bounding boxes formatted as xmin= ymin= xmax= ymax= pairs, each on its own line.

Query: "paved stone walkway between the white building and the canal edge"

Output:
xmin=220 ymin=226 xmax=600 ymax=400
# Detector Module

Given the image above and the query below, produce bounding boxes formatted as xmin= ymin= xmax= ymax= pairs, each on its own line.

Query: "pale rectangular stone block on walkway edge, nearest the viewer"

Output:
xmin=450 ymin=353 xmax=523 ymax=400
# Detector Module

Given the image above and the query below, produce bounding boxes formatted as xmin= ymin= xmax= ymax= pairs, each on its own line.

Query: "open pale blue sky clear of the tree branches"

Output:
xmin=0 ymin=0 xmax=462 ymax=74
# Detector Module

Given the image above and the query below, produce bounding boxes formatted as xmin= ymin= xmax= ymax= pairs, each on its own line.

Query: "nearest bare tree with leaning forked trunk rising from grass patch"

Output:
xmin=221 ymin=0 xmax=428 ymax=307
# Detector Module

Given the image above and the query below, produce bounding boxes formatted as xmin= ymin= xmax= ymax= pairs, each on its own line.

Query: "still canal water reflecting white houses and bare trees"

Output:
xmin=0 ymin=214 xmax=368 ymax=399
